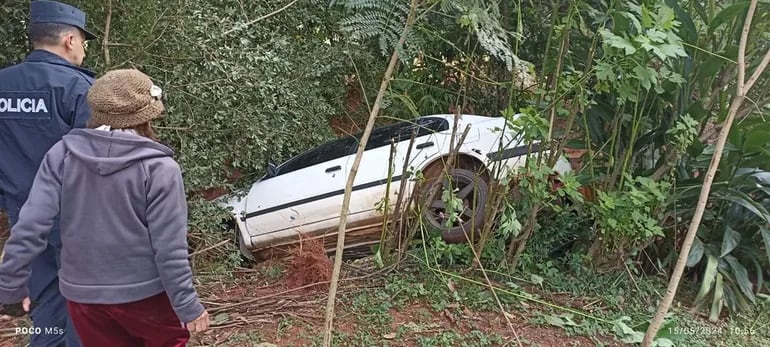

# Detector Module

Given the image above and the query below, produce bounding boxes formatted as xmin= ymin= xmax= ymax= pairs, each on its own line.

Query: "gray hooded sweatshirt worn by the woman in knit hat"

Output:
xmin=0 ymin=129 xmax=204 ymax=322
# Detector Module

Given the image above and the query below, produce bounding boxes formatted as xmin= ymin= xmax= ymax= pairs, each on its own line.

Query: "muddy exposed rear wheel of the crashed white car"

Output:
xmin=420 ymin=169 xmax=489 ymax=243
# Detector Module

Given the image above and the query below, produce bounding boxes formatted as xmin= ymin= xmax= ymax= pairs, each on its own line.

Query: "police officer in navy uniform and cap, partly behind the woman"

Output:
xmin=0 ymin=1 xmax=98 ymax=347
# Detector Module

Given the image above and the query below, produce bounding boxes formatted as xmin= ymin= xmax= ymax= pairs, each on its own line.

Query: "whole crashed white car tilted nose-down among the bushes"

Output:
xmin=221 ymin=114 xmax=570 ymax=258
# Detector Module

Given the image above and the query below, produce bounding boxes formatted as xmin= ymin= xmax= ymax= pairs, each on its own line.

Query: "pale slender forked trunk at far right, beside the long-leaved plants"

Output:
xmin=642 ymin=0 xmax=770 ymax=347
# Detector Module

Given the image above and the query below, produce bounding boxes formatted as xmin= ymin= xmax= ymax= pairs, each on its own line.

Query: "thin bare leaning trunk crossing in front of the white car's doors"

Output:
xmin=323 ymin=0 xmax=419 ymax=347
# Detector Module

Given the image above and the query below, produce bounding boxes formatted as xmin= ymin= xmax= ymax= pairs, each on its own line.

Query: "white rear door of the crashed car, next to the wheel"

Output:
xmin=348 ymin=117 xmax=449 ymax=223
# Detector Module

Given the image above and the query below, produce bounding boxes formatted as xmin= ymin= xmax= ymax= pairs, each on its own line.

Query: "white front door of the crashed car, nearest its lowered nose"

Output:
xmin=240 ymin=136 xmax=356 ymax=245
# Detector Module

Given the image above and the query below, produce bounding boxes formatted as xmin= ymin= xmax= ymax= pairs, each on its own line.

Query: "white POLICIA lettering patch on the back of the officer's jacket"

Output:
xmin=0 ymin=90 xmax=55 ymax=120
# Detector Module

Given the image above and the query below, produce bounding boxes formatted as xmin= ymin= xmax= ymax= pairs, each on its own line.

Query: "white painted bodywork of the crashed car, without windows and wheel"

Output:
xmin=222 ymin=115 xmax=570 ymax=253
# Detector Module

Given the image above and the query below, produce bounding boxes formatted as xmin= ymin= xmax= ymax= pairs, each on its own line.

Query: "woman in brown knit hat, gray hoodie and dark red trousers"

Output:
xmin=0 ymin=69 xmax=209 ymax=347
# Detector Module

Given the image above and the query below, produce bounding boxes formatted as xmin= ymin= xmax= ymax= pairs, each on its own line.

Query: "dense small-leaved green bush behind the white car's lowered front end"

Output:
xmin=164 ymin=2 xmax=342 ymax=187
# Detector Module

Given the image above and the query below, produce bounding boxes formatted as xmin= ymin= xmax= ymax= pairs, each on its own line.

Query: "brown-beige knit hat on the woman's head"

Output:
xmin=88 ymin=69 xmax=165 ymax=129
